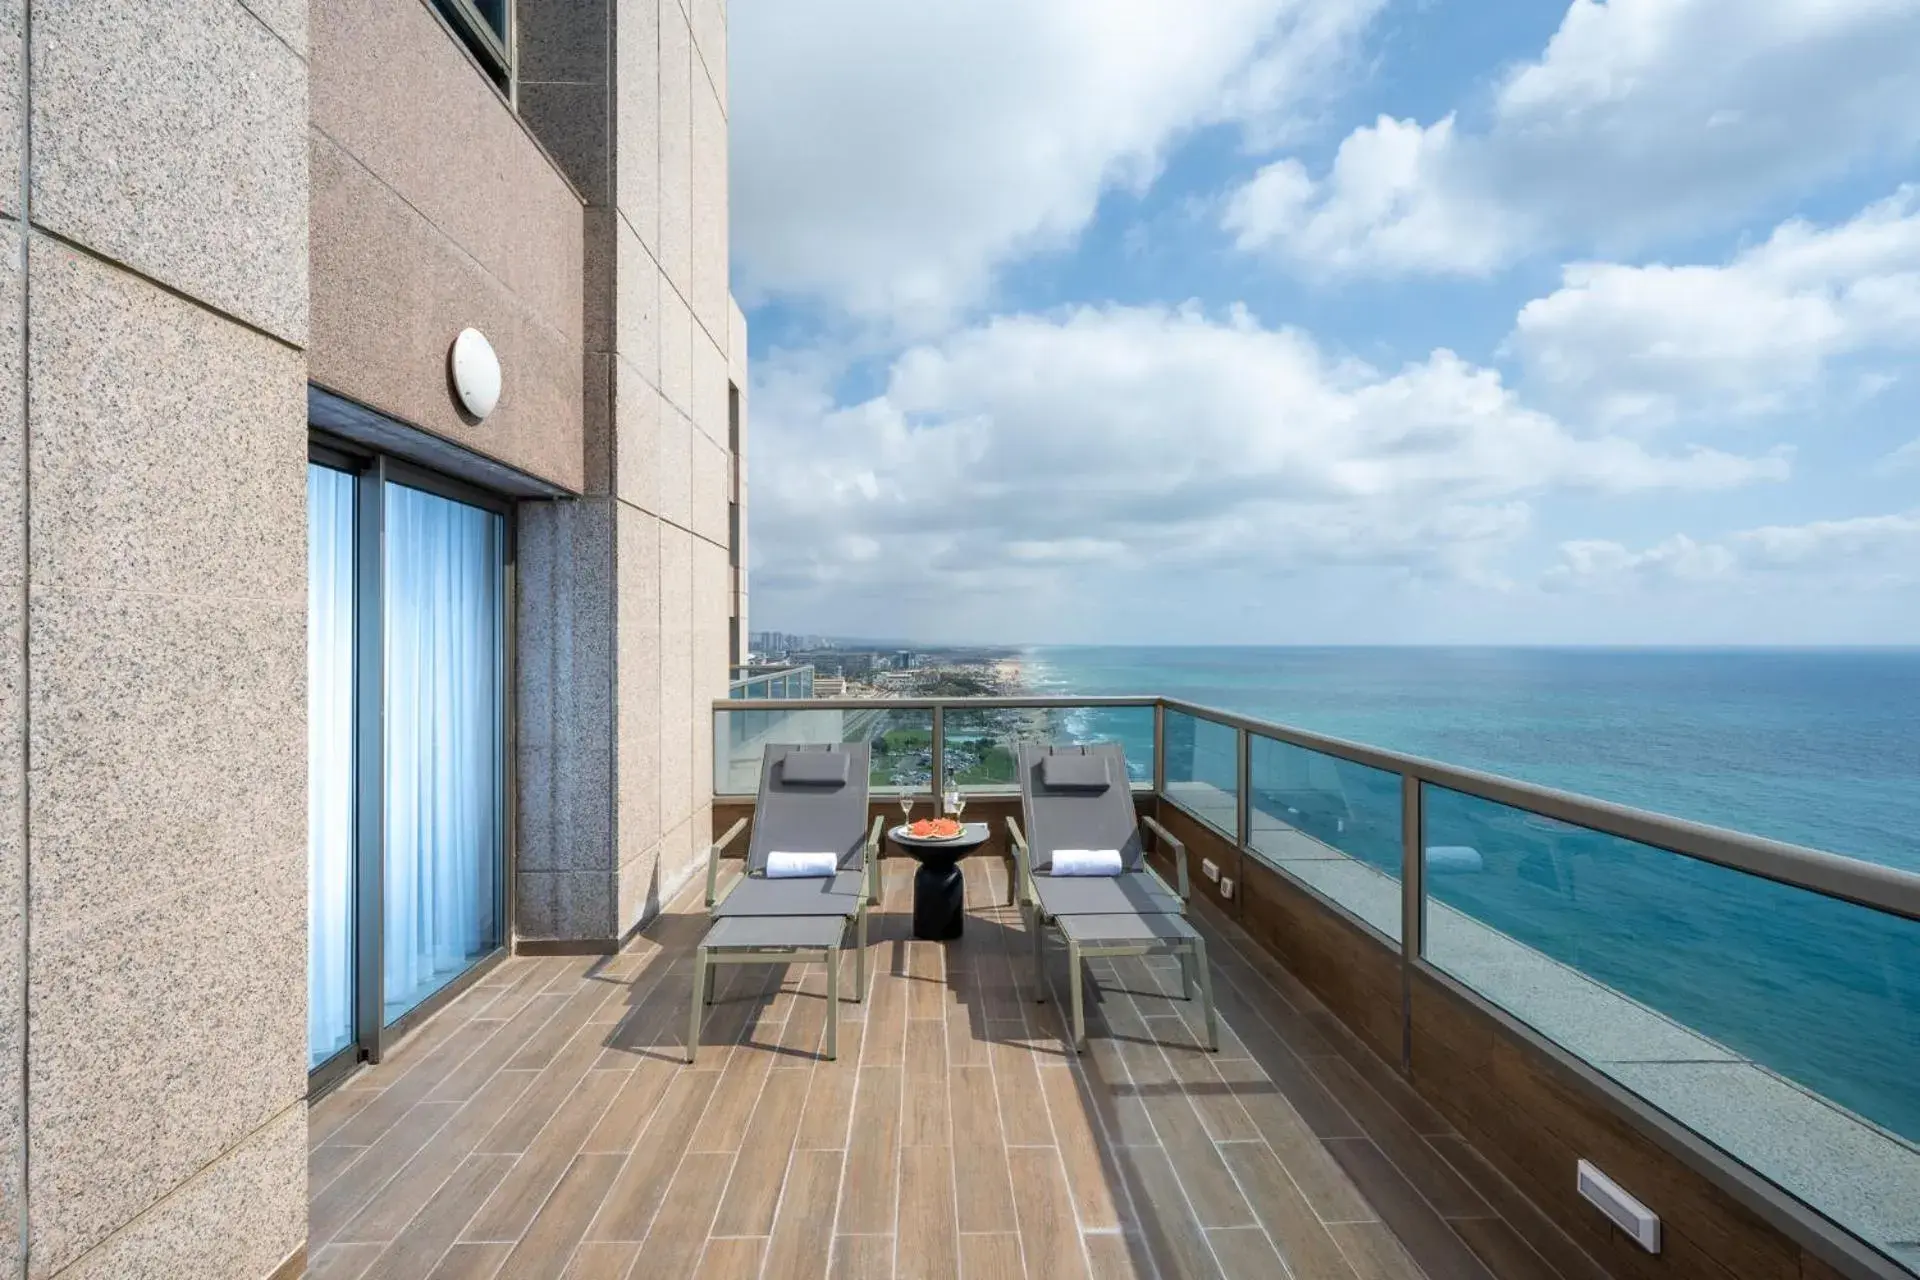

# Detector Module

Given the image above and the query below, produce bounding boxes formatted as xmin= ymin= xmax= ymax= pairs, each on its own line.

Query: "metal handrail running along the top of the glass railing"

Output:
xmin=714 ymin=695 xmax=1920 ymax=921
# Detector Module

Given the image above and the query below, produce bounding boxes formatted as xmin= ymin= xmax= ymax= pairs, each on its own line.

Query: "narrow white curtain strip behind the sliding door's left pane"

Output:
xmin=307 ymin=464 xmax=353 ymax=1067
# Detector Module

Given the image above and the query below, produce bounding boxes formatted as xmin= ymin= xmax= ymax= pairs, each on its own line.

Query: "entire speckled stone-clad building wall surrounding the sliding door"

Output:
xmin=0 ymin=0 xmax=745 ymax=1280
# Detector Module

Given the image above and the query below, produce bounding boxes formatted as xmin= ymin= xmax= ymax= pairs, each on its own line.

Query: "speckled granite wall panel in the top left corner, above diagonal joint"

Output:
xmin=31 ymin=0 xmax=307 ymax=345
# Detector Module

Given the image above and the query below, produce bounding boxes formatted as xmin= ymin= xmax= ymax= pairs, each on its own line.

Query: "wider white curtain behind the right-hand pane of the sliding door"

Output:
xmin=384 ymin=484 xmax=505 ymax=1021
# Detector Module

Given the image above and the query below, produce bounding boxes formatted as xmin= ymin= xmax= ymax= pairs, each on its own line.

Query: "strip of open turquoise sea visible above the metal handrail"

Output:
xmin=1021 ymin=647 xmax=1920 ymax=871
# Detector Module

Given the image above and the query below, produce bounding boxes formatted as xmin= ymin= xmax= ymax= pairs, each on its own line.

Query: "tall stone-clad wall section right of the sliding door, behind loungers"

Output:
xmin=516 ymin=0 xmax=747 ymax=940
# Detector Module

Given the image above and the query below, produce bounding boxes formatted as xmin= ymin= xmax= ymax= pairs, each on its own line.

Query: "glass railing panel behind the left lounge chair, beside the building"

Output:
xmin=714 ymin=706 xmax=933 ymax=796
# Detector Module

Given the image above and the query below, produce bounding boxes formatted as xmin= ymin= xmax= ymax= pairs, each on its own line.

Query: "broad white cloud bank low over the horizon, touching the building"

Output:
xmin=753 ymin=307 xmax=1786 ymax=635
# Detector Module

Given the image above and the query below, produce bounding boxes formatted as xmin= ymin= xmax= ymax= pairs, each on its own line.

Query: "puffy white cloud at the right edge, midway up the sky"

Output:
xmin=1507 ymin=188 xmax=1920 ymax=422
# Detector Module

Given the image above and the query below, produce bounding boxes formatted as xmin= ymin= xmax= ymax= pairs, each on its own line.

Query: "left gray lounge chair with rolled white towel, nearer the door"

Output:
xmin=687 ymin=743 xmax=883 ymax=1061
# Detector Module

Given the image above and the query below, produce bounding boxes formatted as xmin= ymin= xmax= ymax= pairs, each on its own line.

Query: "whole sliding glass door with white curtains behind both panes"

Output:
xmin=307 ymin=447 xmax=509 ymax=1086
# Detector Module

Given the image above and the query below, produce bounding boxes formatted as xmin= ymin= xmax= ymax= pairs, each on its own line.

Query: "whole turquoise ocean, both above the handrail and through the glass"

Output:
xmin=1021 ymin=647 xmax=1920 ymax=1144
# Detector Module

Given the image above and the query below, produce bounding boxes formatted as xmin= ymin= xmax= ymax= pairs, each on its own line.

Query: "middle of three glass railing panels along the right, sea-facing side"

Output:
xmin=1246 ymin=733 xmax=1402 ymax=942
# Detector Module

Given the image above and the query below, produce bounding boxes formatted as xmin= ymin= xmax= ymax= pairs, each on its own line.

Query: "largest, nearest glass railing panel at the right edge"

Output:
xmin=1423 ymin=787 xmax=1920 ymax=1267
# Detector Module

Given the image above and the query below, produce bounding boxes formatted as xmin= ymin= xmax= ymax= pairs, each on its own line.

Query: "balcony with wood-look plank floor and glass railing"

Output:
xmin=309 ymin=699 xmax=1920 ymax=1280
